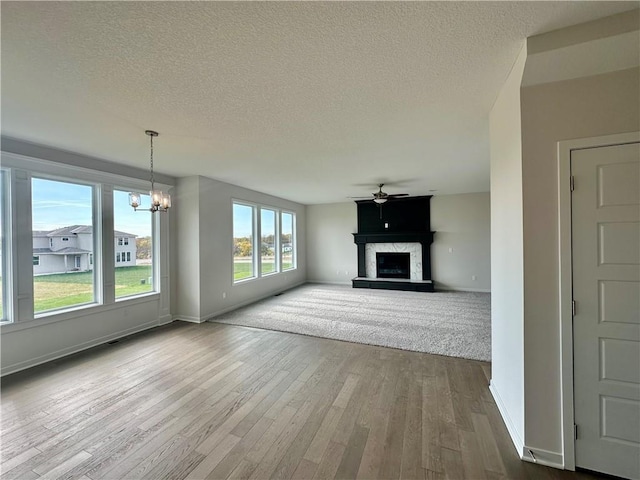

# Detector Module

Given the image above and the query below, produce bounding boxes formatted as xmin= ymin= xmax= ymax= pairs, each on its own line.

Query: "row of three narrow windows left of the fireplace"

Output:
xmin=233 ymin=201 xmax=296 ymax=282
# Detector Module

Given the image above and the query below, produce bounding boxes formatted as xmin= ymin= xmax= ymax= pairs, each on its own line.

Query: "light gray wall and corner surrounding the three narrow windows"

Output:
xmin=173 ymin=176 xmax=307 ymax=322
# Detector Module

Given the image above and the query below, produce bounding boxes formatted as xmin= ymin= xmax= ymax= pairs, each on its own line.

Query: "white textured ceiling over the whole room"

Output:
xmin=1 ymin=1 xmax=637 ymax=204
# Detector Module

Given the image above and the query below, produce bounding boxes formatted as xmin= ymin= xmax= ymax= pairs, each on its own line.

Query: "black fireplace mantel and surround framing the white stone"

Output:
xmin=353 ymin=195 xmax=436 ymax=291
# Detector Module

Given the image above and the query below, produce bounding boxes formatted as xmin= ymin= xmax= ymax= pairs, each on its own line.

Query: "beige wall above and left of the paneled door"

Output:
xmin=522 ymin=68 xmax=640 ymax=452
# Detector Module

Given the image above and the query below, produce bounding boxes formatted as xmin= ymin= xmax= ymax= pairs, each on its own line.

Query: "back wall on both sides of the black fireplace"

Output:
xmin=307 ymin=193 xmax=491 ymax=291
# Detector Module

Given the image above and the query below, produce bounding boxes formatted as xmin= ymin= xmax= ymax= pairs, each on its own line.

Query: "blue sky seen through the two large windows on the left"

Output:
xmin=31 ymin=178 xmax=152 ymax=237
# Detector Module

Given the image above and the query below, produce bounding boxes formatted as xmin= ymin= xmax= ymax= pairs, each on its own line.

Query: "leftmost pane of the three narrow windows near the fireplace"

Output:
xmin=233 ymin=203 xmax=255 ymax=281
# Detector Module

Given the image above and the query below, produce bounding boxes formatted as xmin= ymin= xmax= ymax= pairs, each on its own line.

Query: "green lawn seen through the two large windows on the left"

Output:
xmin=33 ymin=265 xmax=153 ymax=313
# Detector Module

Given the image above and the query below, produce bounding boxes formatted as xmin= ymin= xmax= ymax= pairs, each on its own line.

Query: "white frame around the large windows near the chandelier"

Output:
xmin=0 ymin=151 xmax=173 ymax=332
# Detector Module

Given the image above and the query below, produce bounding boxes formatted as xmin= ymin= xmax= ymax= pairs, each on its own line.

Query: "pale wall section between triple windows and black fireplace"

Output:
xmin=307 ymin=202 xmax=358 ymax=285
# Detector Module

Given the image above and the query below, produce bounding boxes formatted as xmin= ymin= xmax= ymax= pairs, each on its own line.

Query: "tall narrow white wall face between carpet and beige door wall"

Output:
xmin=489 ymin=47 xmax=527 ymax=454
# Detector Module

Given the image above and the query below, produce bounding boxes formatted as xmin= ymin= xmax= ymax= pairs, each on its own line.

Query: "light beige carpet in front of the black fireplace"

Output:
xmin=211 ymin=284 xmax=491 ymax=361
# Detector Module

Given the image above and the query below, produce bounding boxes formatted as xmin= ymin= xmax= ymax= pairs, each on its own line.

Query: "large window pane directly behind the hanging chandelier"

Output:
xmin=113 ymin=190 xmax=152 ymax=298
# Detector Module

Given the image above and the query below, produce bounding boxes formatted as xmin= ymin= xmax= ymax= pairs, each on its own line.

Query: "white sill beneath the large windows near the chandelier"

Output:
xmin=0 ymin=292 xmax=160 ymax=334
